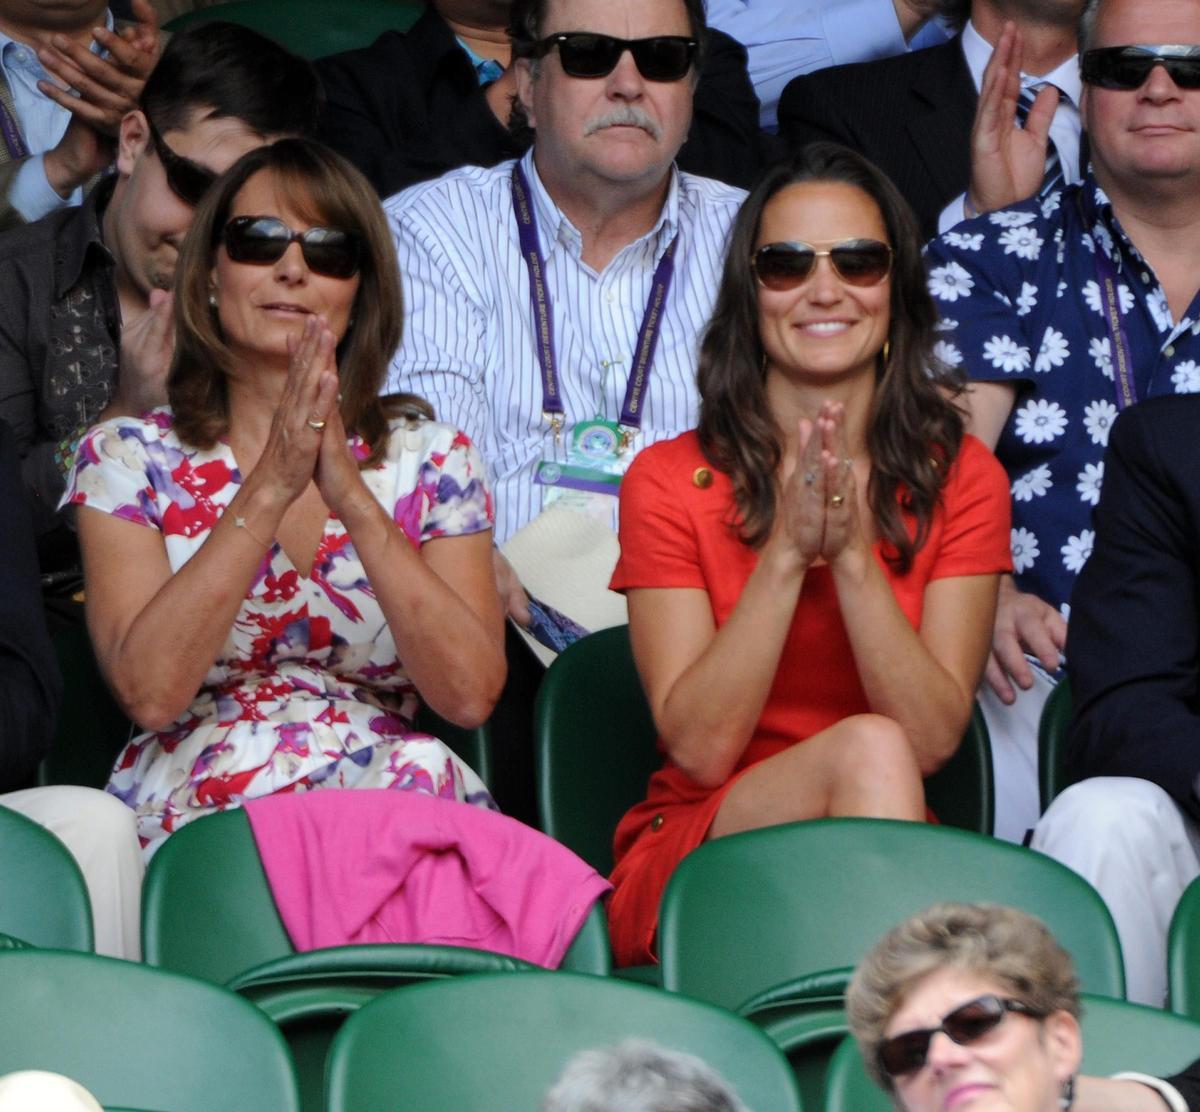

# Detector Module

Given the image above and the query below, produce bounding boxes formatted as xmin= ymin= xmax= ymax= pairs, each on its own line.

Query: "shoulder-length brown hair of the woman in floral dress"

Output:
xmin=167 ymin=138 xmax=432 ymax=467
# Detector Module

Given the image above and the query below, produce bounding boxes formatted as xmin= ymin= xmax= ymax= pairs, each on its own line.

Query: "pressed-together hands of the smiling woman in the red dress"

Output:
xmin=768 ymin=402 xmax=866 ymax=571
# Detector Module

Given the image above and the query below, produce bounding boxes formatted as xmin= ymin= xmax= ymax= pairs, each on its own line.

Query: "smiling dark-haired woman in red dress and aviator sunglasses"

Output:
xmin=610 ymin=144 xmax=1009 ymax=962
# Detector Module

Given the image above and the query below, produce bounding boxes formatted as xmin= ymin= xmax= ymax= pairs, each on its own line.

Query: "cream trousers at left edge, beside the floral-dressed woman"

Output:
xmin=0 ymin=785 xmax=145 ymax=961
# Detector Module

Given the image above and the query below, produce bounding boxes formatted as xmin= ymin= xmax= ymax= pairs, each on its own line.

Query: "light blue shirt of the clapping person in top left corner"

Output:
xmin=0 ymin=12 xmax=113 ymax=222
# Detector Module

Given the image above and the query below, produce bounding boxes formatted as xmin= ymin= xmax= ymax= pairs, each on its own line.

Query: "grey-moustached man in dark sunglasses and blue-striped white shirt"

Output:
xmin=385 ymin=0 xmax=745 ymax=815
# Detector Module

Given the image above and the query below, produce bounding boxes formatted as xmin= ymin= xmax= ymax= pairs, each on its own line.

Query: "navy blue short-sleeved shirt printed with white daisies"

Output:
xmin=925 ymin=175 xmax=1200 ymax=613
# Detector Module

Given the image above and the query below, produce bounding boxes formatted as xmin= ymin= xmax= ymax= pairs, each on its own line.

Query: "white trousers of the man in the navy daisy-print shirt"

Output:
xmin=976 ymin=661 xmax=1055 ymax=844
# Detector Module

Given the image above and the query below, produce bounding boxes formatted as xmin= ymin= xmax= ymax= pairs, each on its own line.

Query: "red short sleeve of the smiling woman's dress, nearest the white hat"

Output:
xmin=608 ymin=440 xmax=708 ymax=590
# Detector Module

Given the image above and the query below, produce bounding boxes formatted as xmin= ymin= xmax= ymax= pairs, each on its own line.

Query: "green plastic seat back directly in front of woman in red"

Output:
xmin=658 ymin=818 xmax=1124 ymax=1008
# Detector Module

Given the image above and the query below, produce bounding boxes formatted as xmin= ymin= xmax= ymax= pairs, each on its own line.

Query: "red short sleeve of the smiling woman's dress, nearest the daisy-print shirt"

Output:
xmin=930 ymin=435 xmax=1013 ymax=579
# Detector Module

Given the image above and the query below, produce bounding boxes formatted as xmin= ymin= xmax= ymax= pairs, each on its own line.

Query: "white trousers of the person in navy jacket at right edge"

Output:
xmin=1033 ymin=776 xmax=1200 ymax=1008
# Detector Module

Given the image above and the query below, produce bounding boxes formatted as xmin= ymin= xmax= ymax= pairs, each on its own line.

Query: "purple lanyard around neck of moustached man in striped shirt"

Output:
xmin=512 ymin=162 xmax=679 ymax=446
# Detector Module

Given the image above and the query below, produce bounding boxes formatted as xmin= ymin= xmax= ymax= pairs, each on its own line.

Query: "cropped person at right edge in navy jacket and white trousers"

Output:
xmin=1034 ymin=395 xmax=1200 ymax=1017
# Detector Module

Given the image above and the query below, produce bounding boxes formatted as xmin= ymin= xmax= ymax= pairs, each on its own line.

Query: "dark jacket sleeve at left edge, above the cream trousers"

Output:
xmin=0 ymin=421 xmax=61 ymax=792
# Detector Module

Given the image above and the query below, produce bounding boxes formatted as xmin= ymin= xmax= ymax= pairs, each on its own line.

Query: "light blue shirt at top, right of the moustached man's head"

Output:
xmin=708 ymin=0 xmax=948 ymax=132
